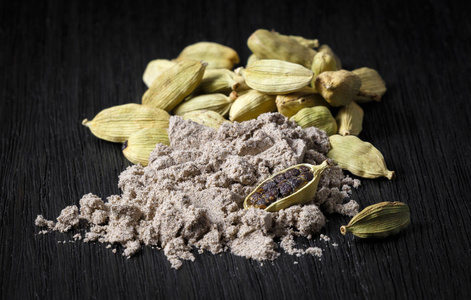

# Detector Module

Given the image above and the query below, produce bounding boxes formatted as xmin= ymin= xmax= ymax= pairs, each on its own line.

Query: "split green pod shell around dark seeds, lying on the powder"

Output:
xmin=244 ymin=160 xmax=330 ymax=212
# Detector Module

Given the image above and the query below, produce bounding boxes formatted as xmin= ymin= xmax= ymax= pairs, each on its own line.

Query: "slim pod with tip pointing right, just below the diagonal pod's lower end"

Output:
xmin=173 ymin=92 xmax=238 ymax=116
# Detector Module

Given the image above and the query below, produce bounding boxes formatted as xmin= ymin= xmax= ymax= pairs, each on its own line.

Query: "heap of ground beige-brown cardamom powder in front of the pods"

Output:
xmin=36 ymin=113 xmax=360 ymax=269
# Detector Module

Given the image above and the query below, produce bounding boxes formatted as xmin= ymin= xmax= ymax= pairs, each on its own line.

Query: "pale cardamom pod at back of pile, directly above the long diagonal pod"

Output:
xmin=176 ymin=42 xmax=239 ymax=69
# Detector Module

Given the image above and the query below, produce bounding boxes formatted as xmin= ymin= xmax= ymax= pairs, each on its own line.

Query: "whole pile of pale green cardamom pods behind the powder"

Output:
xmin=83 ymin=29 xmax=394 ymax=179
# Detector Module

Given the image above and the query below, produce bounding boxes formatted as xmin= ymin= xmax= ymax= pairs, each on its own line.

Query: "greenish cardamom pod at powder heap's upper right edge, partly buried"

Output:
xmin=289 ymin=106 xmax=337 ymax=136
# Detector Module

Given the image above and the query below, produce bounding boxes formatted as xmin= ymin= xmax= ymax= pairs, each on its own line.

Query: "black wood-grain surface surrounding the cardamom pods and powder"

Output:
xmin=0 ymin=0 xmax=471 ymax=299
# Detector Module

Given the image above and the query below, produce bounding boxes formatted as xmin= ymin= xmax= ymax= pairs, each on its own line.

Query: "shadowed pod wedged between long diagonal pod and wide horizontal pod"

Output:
xmin=193 ymin=69 xmax=245 ymax=95
